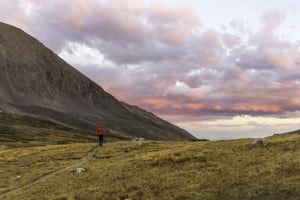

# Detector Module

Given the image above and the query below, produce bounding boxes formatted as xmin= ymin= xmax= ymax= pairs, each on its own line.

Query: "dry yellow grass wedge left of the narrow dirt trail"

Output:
xmin=0 ymin=144 xmax=92 ymax=193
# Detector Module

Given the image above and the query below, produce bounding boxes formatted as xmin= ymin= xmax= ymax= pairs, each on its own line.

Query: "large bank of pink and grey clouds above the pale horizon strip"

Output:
xmin=0 ymin=0 xmax=300 ymax=118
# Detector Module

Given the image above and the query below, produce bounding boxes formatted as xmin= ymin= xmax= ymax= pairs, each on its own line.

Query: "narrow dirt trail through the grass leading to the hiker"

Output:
xmin=0 ymin=146 xmax=99 ymax=199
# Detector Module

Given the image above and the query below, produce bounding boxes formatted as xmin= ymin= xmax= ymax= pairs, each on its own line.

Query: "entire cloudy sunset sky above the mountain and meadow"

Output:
xmin=0 ymin=0 xmax=300 ymax=140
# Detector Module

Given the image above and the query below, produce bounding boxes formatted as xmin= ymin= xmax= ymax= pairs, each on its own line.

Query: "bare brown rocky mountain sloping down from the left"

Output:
xmin=0 ymin=23 xmax=194 ymax=140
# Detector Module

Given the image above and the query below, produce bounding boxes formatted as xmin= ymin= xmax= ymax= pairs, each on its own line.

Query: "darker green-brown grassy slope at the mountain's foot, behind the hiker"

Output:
xmin=0 ymin=113 xmax=124 ymax=146
